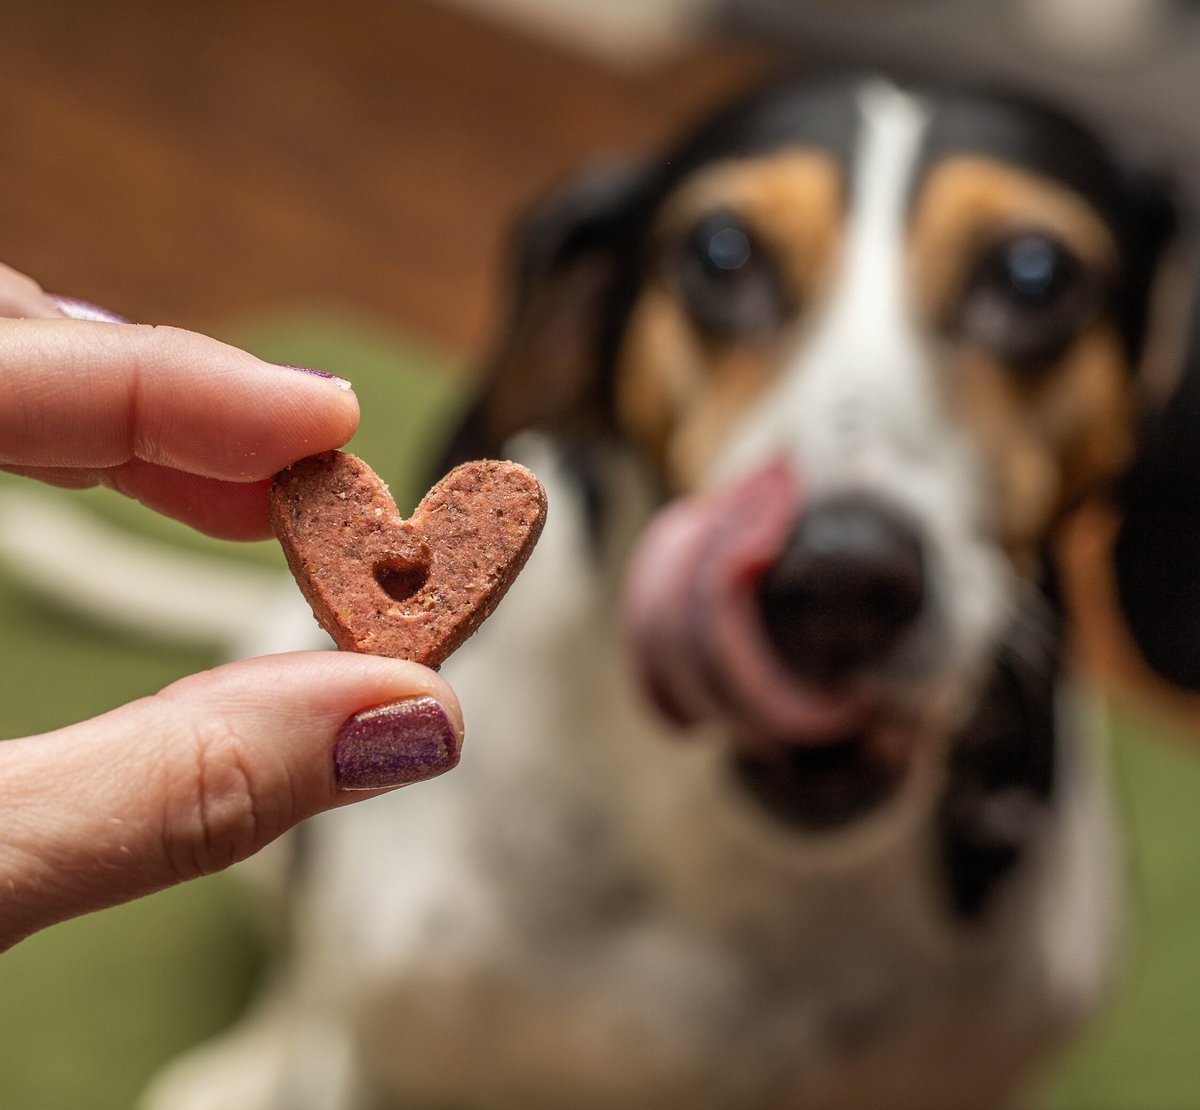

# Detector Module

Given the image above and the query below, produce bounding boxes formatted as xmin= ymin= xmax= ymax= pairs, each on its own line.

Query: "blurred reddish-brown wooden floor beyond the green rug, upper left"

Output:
xmin=0 ymin=0 xmax=762 ymax=353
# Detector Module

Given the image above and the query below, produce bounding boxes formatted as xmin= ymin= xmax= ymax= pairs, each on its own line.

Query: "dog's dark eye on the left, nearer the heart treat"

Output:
xmin=674 ymin=211 xmax=787 ymax=338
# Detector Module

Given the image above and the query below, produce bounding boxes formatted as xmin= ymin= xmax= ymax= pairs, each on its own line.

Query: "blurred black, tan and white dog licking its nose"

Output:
xmin=112 ymin=77 xmax=1200 ymax=1110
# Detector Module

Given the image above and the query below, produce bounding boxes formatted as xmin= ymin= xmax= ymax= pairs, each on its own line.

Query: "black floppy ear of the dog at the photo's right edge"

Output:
xmin=1114 ymin=204 xmax=1200 ymax=690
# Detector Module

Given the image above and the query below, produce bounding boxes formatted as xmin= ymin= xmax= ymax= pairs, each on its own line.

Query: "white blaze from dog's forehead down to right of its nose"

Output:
xmin=710 ymin=82 xmax=1006 ymax=691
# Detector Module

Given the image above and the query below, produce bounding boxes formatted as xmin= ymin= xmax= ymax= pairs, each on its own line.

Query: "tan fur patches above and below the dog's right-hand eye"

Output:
xmin=910 ymin=156 xmax=1132 ymax=565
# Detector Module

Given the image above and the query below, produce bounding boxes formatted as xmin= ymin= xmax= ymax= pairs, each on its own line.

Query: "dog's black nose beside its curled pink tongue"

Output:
xmin=758 ymin=497 xmax=925 ymax=684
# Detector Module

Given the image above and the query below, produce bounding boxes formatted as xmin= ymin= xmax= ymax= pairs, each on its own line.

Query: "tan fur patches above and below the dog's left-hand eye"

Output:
xmin=617 ymin=151 xmax=842 ymax=490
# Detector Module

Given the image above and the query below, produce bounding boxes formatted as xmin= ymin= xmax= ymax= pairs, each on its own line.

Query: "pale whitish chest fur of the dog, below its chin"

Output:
xmin=290 ymin=444 xmax=1111 ymax=1108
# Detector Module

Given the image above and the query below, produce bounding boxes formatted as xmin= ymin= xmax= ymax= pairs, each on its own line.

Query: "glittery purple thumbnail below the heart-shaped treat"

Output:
xmin=334 ymin=697 xmax=458 ymax=790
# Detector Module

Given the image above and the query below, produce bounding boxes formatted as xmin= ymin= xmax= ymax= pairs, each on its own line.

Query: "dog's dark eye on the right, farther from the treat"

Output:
xmin=958 ymin=234 xmax=1099 ymax=371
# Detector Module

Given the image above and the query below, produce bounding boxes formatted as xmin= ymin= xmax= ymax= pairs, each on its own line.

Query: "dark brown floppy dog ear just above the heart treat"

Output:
xmin=448 ymin=164 xmax=647 ymax=462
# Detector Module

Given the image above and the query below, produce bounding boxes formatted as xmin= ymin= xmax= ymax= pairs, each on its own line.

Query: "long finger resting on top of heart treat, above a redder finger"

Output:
xmin=0 ymin=319 xmax=359 ymax=482
